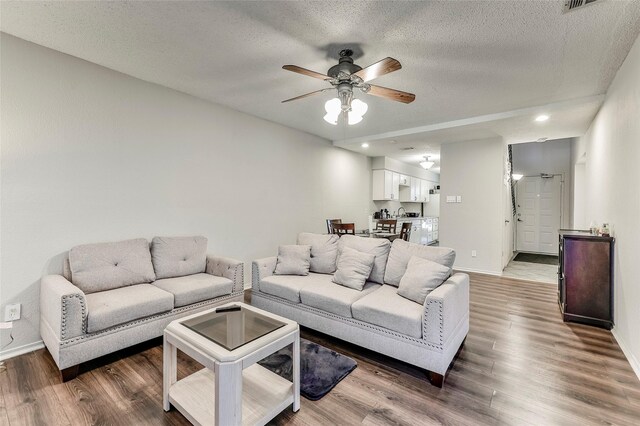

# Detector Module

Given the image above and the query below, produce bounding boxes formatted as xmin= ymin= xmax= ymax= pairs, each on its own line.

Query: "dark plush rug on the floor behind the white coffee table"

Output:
xmin=258 ymin=339 xmax=358 ymax=401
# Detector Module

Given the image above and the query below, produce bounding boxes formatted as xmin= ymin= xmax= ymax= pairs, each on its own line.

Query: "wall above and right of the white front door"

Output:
xmin=512 ymin=139 xmax=573 ymax=228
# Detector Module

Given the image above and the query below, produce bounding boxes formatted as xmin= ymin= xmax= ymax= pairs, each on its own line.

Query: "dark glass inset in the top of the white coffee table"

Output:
xmin=181 ymin=307 xmax=286 ymax=351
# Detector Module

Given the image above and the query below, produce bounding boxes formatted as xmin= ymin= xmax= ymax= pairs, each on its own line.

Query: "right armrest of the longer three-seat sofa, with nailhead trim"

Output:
xmin=422 ymin=273 xmax=469 ymax=346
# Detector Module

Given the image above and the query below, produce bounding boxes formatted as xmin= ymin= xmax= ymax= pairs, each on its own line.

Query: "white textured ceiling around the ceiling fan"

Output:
xmin=0 ymin=0 xmax=640 ymax=168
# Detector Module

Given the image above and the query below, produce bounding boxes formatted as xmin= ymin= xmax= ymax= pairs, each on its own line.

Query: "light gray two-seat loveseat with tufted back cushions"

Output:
xmin=40 ymin=237 xmax=244 ymax=381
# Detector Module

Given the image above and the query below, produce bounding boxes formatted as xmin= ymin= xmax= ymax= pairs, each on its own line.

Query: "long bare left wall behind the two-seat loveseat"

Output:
xmin=0 ymin=34 xmax=371 ymax=355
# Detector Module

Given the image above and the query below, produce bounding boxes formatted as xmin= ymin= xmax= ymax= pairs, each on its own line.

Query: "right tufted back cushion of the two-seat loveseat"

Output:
xmin=151 ymin=237 xmax=207 ymax=279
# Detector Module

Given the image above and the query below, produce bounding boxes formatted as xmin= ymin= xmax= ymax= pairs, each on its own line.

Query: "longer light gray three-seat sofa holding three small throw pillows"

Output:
xmin=251 ymin=233 xmax=469 ymax=387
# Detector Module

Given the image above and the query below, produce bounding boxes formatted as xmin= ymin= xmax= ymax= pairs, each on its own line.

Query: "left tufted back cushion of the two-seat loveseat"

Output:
xmin=69 ymin=238 xmax=156 ymax=294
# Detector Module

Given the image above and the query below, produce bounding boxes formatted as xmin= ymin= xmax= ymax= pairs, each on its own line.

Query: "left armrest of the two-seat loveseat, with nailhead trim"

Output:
xmin=40 ymin=275 xmax=88 ymax=341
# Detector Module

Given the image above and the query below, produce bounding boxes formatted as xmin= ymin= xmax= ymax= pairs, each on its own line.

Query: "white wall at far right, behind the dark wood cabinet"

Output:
xmin=573 ymin=33 xmax=640 ymax=377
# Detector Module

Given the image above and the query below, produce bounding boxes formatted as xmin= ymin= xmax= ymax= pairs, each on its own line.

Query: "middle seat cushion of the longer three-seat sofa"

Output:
xmin=300 ymin=282 xmax=380 ymax=318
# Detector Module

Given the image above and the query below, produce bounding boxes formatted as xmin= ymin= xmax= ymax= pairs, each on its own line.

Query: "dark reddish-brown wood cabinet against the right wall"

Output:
xmin=558 ymin=230 xmax=614 ymax=330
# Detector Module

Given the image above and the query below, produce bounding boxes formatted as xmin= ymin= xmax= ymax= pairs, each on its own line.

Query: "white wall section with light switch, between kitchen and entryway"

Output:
xmin=439 ymin=139 xmax=504 ymax=274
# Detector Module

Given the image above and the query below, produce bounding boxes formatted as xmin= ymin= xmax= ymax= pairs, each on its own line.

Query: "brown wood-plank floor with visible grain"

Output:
xmin=0 ymin=274 xmax=640 ymax=425
